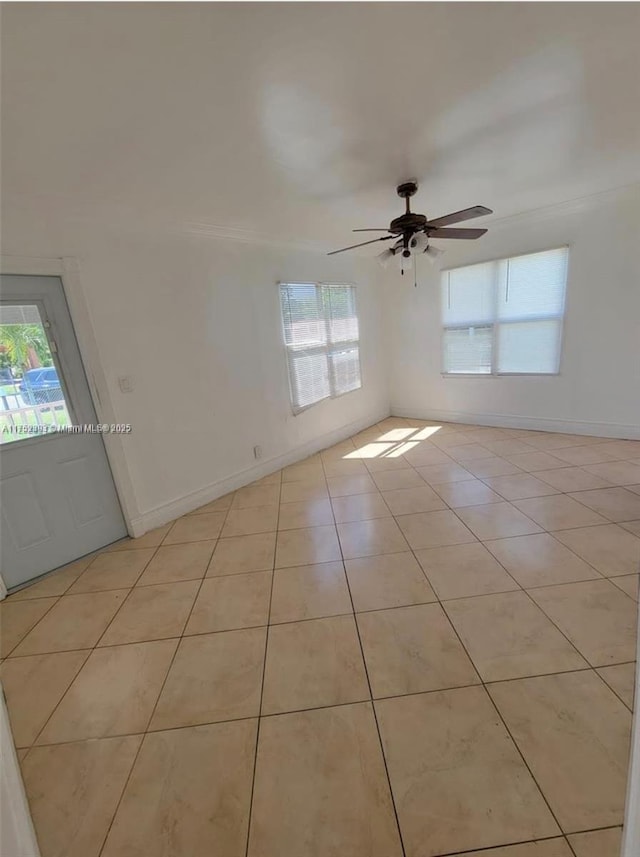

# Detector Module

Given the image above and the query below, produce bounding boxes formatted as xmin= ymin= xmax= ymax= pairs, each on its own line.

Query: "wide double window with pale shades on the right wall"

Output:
xmin=442 ymin=247 xmax=569 ymax=375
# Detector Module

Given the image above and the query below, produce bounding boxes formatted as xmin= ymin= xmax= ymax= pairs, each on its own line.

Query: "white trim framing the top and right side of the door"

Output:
xmin=0 ymin=255 xmax=140 ymax=535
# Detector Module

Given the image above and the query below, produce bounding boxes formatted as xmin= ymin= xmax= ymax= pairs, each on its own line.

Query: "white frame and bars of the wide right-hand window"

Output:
xmin=440 ymin=244 xmax=571 ymax=378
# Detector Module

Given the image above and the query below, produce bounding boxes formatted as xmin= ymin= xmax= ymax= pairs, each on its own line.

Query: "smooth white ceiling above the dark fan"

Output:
xmin=2 ymin=3 xmax=640 ymax=246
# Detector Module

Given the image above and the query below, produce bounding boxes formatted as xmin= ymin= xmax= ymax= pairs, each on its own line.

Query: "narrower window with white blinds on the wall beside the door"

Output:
xmin=280 ymin=283 xmax=362 ymax=413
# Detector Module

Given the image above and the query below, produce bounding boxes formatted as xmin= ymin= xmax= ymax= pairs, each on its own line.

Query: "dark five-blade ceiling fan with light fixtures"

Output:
xmin=327 ymin=181 xmax=493 ymax=270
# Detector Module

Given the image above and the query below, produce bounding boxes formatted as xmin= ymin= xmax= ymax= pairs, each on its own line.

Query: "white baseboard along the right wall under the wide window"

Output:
xmin=391 ymin=407 xmax=640 ymax=440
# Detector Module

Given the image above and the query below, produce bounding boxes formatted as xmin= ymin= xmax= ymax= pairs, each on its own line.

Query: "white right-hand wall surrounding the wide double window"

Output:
xmin=385 ymin=185 xmax=640 ymax=437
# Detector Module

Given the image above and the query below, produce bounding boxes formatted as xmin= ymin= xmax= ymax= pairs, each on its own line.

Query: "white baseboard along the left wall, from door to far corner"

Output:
xmin=128 ymin=410 xmax=389 ymax=538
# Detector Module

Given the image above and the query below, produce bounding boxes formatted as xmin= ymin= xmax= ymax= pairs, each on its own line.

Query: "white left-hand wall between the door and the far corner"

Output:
xmin=2 ymin=216 xmax=389 ymax=534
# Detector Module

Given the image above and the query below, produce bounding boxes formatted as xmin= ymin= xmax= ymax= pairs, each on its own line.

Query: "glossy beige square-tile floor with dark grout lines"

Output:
xmin=0 ymin=418 xmax=640 ymax=857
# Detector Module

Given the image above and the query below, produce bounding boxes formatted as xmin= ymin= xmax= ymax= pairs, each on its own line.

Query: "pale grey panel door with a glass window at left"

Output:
xmin=0 ymin=276 xmax=126 ymax=589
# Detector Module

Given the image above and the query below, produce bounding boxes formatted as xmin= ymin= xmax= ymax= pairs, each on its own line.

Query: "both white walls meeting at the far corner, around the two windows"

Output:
xmin=2 ymin=186 xmax=640 ymax=534
